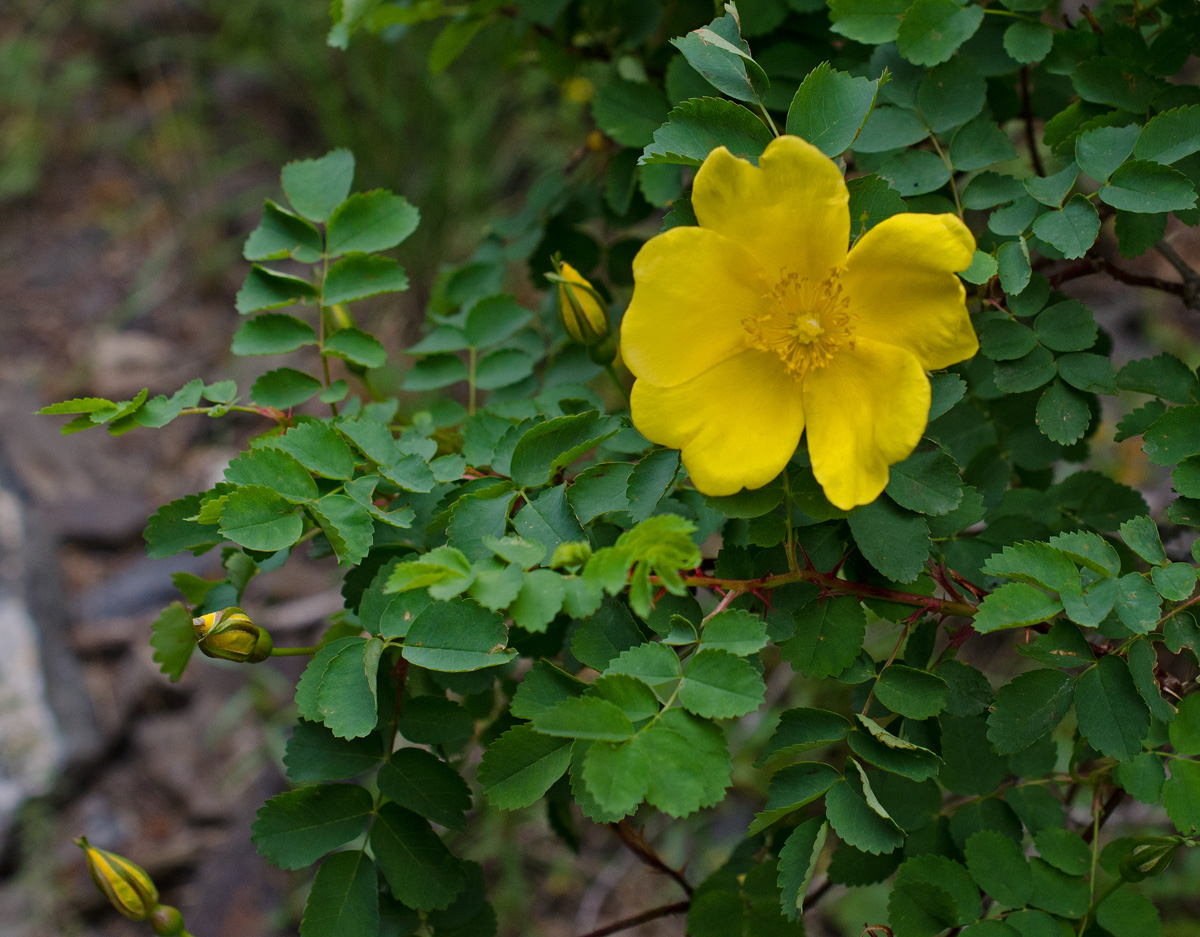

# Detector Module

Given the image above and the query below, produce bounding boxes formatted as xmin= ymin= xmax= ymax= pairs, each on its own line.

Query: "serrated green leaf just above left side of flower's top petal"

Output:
xmin=638 ymin=97 xmax=772 ymax=166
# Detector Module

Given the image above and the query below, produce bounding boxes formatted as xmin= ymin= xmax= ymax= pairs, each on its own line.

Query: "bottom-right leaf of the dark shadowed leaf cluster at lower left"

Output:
xmin=371 ymin=804 xmax=467 ymax=911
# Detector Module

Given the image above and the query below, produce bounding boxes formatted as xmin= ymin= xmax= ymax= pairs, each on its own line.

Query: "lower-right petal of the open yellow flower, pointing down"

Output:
xmin=803 ymin=338 xmax=929 ymax=511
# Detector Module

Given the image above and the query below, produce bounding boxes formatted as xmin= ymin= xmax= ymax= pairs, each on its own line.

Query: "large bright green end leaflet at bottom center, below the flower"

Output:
xmin=641 ymin=709 xmax=732 ymax=818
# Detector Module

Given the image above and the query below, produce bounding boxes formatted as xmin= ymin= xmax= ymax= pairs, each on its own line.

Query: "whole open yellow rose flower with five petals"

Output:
xmin=620 ymin=137 xmax=979 ymax=510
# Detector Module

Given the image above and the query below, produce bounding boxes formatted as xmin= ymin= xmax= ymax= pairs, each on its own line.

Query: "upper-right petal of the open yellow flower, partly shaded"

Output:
xmin=842 ymin=214 xmax=979 ymax=371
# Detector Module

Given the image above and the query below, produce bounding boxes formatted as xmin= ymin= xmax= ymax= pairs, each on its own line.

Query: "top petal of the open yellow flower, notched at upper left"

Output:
xmin=691 ymin=137 xmax=850 ymax=281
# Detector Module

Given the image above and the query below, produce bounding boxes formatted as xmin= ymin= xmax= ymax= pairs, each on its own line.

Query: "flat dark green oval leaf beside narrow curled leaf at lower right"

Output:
xmin=1075 ymin=654 xmax=1150 ymax=762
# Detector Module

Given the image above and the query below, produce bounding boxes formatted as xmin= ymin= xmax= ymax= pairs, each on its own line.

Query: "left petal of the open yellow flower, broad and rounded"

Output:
xmin=620 ymin=227 xmax=768 ymax=388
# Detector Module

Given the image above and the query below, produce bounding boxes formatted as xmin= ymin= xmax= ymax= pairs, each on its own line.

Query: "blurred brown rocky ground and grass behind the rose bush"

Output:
xmin=7 ymin=0 xmax=1200 ymax=937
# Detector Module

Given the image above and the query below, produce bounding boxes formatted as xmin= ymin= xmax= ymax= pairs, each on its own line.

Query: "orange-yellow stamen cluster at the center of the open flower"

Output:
xmin=742 ymin=269 xmax=857 ymax=379
